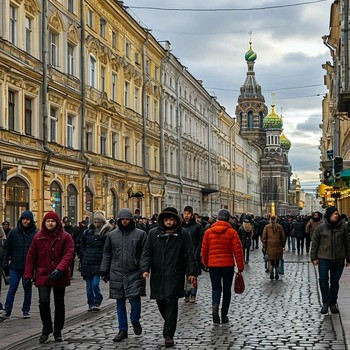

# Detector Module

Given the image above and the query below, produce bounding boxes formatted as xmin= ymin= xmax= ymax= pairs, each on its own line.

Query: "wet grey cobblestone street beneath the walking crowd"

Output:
xmin=0 ymin=250 xmax=346 ymax=350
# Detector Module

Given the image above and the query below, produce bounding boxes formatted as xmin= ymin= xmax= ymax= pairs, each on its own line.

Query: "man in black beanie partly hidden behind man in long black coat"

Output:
xmin=182 ymin=205 xmax=204 ymax=303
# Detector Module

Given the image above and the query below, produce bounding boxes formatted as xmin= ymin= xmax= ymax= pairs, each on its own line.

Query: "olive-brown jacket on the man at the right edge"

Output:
xmin=310 ymin=218 xmax=350 ymax=262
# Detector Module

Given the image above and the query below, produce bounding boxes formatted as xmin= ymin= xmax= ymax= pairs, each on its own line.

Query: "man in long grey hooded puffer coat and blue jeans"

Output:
xmin=100 ymin=208 xmax=147 ymax=342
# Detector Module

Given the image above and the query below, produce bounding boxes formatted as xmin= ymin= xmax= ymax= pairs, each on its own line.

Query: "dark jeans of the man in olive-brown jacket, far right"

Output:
xmin=318 ymin=259 xmax=344 ymax=305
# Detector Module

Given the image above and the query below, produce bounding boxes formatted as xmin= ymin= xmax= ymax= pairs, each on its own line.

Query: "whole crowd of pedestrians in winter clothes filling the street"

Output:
xmin=0 ymin=206 xmax=350 ymax=347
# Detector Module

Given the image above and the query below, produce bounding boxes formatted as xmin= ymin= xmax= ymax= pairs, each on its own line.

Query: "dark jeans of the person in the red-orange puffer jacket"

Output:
xmin=209 ymin=266 xmax=234 ymax=315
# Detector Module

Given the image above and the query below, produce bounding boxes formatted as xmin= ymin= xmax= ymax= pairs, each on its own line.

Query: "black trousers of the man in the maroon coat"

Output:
xmin=38 ymin=286 xmax=66 ymax=335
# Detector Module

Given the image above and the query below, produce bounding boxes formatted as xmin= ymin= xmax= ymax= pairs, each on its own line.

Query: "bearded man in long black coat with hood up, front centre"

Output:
xmin=141 ymin=207 xmax=198 ymax=348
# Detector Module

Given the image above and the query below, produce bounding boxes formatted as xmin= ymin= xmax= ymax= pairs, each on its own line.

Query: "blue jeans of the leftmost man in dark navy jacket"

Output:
xmin=5 ymin=269 xmax=32 ymax=315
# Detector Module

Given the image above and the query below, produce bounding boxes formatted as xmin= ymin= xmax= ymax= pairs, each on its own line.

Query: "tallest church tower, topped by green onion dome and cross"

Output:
xmin=235 ymin=39 xmax=267 ymax=148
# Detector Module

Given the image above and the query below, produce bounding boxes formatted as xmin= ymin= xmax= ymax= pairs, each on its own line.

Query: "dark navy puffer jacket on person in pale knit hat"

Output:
xmin=79 ymin=224 xmax=112 ymax=278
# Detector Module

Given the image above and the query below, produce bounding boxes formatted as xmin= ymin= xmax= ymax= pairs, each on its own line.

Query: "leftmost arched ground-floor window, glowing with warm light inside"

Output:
xmin=5 ymin=176 xmax=30 ymax=227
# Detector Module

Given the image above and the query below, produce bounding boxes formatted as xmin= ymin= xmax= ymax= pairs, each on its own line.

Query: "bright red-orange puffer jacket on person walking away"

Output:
xmin=202 ymin=220 xmax=244 ymax=271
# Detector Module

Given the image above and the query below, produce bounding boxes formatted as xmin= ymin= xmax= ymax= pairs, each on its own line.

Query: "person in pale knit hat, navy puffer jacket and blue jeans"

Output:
xmin=80 ymin=212 xmax=112 ymax=311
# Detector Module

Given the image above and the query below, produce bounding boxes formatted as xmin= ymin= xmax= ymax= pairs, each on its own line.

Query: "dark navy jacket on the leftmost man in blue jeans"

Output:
xmin=2 ymin=220 xmax=38 ymax=271
